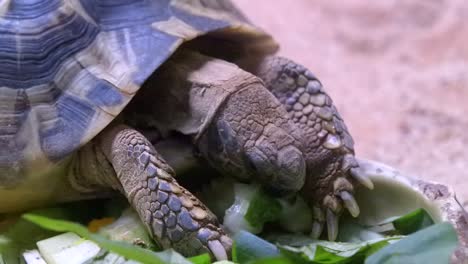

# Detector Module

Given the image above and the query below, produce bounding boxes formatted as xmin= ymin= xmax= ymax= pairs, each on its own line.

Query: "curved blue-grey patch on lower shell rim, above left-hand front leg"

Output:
xmin=39 ymin=95 xmax=95 ymax=161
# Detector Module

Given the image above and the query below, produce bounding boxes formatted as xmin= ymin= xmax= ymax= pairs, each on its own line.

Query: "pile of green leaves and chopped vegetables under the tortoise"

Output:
xmin=0 ymin=184 xmax=457 ymax=264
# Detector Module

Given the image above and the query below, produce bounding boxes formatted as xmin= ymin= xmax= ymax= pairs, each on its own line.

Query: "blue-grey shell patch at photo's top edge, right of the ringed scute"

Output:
xmin=81 ymin=0 xmax=171 ymax=31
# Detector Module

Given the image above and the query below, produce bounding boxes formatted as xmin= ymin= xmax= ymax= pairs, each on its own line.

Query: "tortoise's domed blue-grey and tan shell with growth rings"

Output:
xmin=0 ymin=0 xmax=274 ymax=182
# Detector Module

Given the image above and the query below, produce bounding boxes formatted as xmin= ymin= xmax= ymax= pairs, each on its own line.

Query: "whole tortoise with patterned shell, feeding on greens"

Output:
xmin=0 ymin=0 xmax=372 ymax=259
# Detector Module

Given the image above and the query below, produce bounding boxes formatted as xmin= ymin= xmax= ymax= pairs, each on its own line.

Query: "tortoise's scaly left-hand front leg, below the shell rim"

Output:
xmin=75 ymin=125 xmax=232 ymax=260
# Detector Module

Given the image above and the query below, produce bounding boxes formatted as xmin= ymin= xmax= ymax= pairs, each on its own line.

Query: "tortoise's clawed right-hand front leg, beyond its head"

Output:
xmin=245 ymin=56 xmax=373 ymax=240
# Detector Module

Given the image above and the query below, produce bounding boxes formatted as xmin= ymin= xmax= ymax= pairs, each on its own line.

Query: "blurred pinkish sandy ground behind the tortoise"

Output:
xmin=234 ymin=0 xmax=468 ymax=205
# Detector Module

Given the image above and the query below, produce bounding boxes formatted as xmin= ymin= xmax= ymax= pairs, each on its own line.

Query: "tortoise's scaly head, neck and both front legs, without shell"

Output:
xmin=74 ymin=51 xmax=372 ymax=260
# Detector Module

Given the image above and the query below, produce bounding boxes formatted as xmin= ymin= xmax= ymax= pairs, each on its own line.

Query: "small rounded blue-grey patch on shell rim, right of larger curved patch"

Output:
xmin=86 ymin=80 xmax=123 ymax=106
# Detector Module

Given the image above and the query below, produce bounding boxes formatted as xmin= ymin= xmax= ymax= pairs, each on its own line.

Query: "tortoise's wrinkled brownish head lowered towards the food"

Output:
xmin=198 ymin=82 xmax=306 ymax=195
